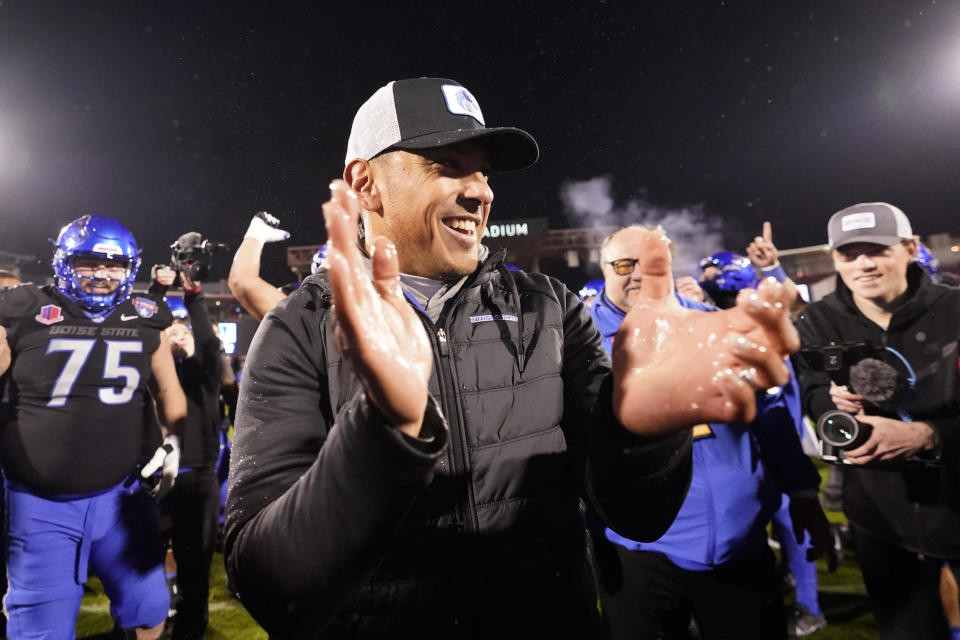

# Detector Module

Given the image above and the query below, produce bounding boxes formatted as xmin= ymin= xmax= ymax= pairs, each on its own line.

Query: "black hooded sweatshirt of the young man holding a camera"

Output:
xmin=796 ymin=265 xmax=960 ymax=558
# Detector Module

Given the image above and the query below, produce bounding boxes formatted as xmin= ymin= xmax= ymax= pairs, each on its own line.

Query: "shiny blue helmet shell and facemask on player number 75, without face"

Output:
xmin=53 ymin=216 xmax=140 ymax=313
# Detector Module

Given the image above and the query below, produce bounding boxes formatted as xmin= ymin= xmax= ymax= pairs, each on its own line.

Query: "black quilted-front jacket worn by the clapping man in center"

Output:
xmin=226 ymin=249 xmax=691 ymax=638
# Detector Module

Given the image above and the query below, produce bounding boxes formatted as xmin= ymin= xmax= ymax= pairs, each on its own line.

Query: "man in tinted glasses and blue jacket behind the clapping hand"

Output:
xmin=591 ymin=226 xmax=830 ymax=640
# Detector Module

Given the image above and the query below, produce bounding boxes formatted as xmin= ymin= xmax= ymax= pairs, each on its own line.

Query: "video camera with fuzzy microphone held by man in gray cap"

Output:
xmin=800 ymin=342 xmax=916 ymax=464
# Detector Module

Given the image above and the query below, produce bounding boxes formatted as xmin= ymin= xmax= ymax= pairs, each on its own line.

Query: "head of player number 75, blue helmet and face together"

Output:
xmin=53 ymin=215 xmax=140 ymax=316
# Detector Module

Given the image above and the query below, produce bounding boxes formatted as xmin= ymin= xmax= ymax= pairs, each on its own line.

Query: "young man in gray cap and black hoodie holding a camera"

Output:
xmin=797 ymin=202 xmax=960 ymax=640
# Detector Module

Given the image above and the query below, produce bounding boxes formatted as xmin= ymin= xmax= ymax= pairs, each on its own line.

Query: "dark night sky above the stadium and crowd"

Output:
xmin=0 ymin=0 xmax=960 ymax=284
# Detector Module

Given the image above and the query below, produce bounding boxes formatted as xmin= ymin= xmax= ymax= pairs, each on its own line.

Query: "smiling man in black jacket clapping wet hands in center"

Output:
xmin=225 ymin=78 xmax=797 ymax=638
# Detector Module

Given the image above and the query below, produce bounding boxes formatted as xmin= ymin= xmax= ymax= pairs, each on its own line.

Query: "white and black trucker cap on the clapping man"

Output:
xmin=344 ymin=78 xmax=540 ymax=171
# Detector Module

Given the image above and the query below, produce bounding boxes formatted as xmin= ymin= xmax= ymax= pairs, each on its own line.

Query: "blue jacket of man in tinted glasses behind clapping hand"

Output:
xmin=590 ymin=291 xmax=820 ymax=571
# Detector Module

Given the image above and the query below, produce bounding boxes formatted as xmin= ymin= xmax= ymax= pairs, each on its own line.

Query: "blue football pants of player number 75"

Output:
xmin=4 ymin=482 xmax=170 ymax=640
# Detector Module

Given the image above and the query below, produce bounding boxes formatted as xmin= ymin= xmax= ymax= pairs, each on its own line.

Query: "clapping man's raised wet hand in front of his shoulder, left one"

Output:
xmin=323 ymin=180 xmax=433 ymax=437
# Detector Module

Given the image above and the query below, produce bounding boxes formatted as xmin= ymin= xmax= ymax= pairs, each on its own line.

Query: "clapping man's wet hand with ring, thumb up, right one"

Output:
xmin=613 ymin=234 xmax=800 ymax=435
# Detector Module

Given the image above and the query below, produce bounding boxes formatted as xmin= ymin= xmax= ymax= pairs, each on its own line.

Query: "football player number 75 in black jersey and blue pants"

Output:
xmin=0 ymin=216 xmax=187 ymax=640
